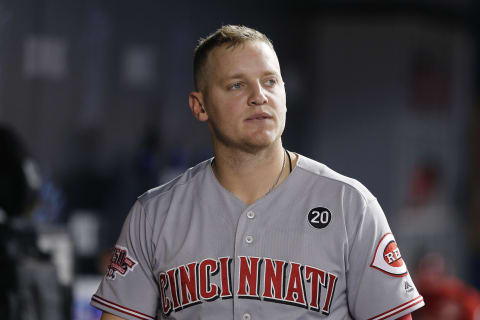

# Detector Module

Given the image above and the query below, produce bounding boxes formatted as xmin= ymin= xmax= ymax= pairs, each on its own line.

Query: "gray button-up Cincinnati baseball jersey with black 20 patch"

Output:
xmin=91 ymin=155 xmax=424 ymax=320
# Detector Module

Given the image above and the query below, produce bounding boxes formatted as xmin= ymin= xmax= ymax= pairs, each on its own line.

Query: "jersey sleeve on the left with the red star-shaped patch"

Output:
xmin=90 ymin=201 xmax=159 ymax=320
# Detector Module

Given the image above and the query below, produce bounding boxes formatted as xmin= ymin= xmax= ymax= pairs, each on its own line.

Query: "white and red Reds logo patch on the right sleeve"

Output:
xmin=370 ymin=233 xmax=408 ymax=277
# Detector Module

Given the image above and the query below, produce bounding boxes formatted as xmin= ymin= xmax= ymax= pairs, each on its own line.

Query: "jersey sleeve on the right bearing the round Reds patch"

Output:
xmin=347 ymin=198 xmax=424 ymax=320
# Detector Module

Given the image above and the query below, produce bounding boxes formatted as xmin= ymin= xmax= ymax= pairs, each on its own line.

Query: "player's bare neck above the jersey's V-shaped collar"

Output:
xmin=214 ymin=139 xmax=290 ymax=205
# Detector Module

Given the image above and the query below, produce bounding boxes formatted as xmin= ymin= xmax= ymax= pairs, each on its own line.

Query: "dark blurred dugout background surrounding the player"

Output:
xmin=0 ymin=0 xmax=480 ymax=319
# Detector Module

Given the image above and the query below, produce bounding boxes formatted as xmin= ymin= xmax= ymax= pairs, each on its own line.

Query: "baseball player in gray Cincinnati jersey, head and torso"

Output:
xmin=91 ymin=26 xmax=424 ymax=320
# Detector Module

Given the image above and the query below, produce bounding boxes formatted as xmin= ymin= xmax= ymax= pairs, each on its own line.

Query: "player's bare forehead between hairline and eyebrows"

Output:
xmin=208 ymin=41 xmax=280 ymax=79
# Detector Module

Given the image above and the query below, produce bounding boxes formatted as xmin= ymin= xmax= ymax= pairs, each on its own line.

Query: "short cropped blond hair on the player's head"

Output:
xmin=193 ymin=25 xmax=273 ymax=91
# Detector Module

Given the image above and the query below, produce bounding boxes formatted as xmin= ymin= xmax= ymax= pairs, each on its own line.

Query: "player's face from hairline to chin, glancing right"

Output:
xmin=197 ymin=41 xmax=287 ymax=152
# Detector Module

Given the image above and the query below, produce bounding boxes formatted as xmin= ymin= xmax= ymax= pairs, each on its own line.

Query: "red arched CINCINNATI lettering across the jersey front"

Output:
xmin=158 ymin=256 xmax=338 ymax=316
